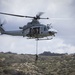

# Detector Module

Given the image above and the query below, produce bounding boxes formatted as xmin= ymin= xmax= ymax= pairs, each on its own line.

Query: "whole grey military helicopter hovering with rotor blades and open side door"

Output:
xmin=0 ymin=12 xmax=57 ymax=39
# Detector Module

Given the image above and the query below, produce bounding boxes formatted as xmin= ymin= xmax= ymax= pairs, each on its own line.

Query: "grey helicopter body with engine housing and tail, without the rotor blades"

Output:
xmin=0 ymin=20 xmax=57 ymax=38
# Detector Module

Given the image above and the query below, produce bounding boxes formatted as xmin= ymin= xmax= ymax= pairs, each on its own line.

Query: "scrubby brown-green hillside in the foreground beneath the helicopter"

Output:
xmin=0 ymin=52 xmax=75 ymax=75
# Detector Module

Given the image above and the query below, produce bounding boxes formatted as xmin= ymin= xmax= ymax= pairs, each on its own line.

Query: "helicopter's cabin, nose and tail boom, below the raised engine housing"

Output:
xmin=2 ymin=25 xmax=55 ymax=38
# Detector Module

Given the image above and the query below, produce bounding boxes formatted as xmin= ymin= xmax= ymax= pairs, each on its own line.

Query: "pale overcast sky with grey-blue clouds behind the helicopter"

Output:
xmin=0 ymin=0 xmax=75 ymax=54
